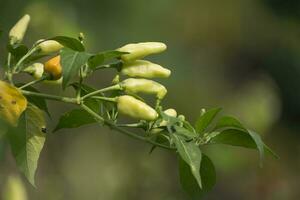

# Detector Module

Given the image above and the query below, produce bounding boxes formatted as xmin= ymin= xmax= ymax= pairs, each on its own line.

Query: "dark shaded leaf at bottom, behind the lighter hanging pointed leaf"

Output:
xmin=179 ymin=154 xmax=216 ymax=200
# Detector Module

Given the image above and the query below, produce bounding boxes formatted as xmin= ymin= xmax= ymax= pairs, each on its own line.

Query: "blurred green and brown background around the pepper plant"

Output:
xmin=0 ymin=0 xmax=300 ymax=200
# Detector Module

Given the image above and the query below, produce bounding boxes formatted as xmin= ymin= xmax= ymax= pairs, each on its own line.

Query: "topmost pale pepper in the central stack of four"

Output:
xmin=117 ymin=42 xmax=167 ymax=62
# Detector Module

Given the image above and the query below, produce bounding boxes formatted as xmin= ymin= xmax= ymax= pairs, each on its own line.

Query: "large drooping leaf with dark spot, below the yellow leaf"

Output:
xmin=8 ymin=104 xmax=46 ymax=185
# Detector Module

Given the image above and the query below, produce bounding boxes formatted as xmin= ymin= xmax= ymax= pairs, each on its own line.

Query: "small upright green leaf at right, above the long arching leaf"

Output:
xmin=195 ymin=108 xmax=221 ymax=133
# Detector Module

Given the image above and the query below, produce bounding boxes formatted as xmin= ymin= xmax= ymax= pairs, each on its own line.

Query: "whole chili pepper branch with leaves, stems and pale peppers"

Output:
xmin=0 ymin=15 xmax=276 ymax=199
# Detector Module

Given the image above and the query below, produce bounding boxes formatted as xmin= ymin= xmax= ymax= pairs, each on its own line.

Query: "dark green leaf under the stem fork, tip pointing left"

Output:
xmin=53 ymin=109 xmax=97 ymax=132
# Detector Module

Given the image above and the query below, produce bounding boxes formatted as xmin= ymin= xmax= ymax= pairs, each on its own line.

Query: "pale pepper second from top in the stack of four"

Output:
xmin=121 ymin=60 xmax=171 ymax=78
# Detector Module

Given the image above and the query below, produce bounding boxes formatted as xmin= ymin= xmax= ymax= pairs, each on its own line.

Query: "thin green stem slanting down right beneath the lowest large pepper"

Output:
xmin=80 ymin=104 xmax=175 ymax=150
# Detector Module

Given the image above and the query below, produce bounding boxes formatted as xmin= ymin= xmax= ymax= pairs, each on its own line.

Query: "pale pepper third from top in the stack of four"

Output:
xmin=120 ymin=78 xmax=167 ymax=99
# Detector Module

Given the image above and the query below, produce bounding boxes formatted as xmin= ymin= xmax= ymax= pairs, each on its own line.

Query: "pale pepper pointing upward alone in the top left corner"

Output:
xmin=9 ymin=14 xmax=30 ymax=44
